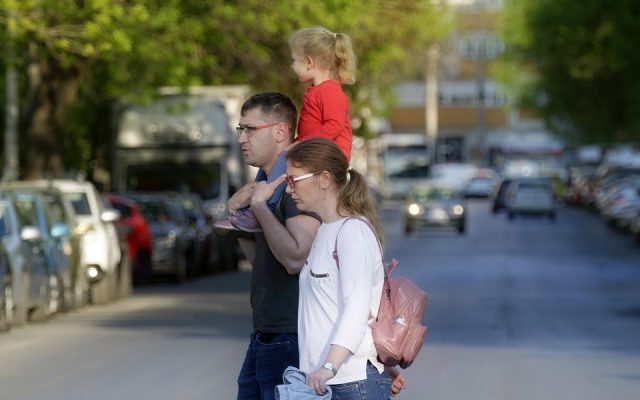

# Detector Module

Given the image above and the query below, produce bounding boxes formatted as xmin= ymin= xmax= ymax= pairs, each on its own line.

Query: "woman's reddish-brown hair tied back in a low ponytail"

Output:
xmin=287 ymin=138 xmax=384 ymax=247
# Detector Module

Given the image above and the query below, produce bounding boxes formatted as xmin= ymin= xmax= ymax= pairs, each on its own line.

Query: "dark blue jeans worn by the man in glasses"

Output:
xmin=238 ymin=332 xmax=299 ymax=400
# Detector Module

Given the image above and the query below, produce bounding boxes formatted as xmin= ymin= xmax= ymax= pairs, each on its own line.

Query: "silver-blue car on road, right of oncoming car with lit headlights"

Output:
xmin=506 ymin=178 xmax=557 ymax=221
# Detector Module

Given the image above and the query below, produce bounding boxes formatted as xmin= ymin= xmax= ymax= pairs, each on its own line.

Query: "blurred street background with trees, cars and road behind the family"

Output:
xmin=0 ymin=0 xmax=640 ymax=400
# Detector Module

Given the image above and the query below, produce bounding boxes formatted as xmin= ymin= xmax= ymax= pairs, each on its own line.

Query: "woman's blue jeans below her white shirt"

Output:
xmin=331 ymin=362 xmax=391 ymax=400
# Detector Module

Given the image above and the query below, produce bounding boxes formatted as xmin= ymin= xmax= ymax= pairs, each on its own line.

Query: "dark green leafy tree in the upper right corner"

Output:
xmin=501 ymin=0 xmax=640 ymax=143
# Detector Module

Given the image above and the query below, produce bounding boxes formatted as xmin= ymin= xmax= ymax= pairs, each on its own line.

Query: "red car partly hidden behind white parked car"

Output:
xmin=107 ymin=194 xmax=151 ymax=283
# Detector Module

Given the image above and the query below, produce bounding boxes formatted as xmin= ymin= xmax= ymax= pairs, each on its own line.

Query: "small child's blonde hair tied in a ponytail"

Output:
xmin=289 ymin=26 xmax=357 ymax=85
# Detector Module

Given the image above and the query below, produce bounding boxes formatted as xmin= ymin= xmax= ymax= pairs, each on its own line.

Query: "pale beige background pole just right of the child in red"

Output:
xmin=425 ymin=43 xmax=440 ymax=164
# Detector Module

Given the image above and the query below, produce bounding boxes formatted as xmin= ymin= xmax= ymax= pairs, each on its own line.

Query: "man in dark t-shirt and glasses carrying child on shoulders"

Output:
xmin=227 ymin=93 xmax=320 ymax=400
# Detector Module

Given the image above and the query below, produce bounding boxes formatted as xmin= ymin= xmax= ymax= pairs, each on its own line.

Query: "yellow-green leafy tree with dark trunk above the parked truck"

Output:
xmin=0 ymin=0 xmax=446 ymax=178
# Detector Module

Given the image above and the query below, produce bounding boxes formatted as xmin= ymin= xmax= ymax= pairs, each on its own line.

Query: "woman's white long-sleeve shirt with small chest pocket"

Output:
xmin=298 ymin=219 xmax=384 ymax=384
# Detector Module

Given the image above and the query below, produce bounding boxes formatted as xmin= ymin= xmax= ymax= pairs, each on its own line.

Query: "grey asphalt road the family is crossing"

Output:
xmin=0 ymin=201 xmax=640 ymax=400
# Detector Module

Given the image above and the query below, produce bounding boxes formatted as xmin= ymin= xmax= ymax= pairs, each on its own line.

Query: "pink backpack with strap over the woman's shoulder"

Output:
xmin=333 ymin=216 xmax=427 ymax=368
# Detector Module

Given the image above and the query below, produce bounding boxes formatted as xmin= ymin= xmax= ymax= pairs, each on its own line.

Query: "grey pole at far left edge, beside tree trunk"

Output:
xmin=2 ymin=10 xmax=18 ymax=182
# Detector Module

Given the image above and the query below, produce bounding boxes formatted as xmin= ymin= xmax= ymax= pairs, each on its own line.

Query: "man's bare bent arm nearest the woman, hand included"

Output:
xmin=251 ymin=176 xmax=320 ymax=274
